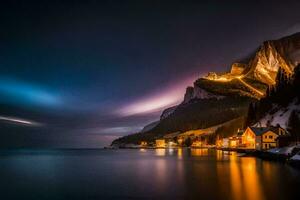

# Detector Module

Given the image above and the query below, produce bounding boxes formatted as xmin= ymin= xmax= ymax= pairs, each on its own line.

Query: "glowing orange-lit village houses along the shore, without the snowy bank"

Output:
xmin=140 ymin=126 xmax=293 ymax=151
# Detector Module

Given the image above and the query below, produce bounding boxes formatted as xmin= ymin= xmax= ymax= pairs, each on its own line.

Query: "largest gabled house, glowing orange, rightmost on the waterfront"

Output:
xmin=239 ymin=127 xmax=286 ymax=150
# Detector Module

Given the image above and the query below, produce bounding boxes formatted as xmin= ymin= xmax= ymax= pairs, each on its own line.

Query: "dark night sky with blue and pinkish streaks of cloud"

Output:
xmin=0 ymin=0 xmax=300 ymax=148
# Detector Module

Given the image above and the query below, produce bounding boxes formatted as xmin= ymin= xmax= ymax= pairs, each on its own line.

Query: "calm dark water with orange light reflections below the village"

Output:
xmin=0 ymin=149 xmax=300 ymax=200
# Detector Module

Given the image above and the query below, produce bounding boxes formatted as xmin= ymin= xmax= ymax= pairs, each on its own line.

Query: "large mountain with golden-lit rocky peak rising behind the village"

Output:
xmin=113 ymin=33 xmax=300 ymax=144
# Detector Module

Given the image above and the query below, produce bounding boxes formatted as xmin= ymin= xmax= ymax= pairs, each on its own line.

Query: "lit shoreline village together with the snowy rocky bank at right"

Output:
xmin=138 ymin=126 xmax=300 ymax=166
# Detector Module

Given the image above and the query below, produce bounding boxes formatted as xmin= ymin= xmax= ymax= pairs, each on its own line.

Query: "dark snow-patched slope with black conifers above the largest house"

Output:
xmin=246 ymin=65 xmax=300 ymax=139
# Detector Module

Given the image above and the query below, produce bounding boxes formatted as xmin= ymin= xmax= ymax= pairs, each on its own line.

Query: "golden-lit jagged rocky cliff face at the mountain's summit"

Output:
xmin=246 ymin=33 xmax=300 ymax=85
